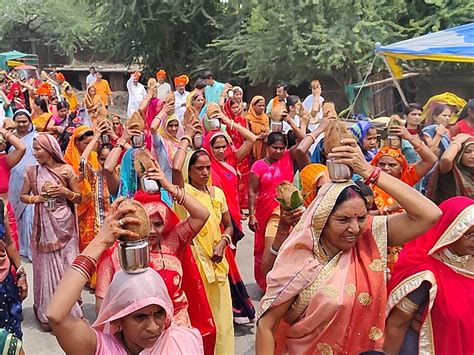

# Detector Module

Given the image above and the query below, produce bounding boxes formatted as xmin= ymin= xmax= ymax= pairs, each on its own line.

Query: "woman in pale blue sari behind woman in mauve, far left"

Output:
xmin=8 ymin=110 xmax=37 ymax=260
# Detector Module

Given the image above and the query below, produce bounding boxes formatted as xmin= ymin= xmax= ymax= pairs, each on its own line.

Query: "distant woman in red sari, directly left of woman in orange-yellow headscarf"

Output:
xmin=224 ymin=98 xmax=250 ymax=210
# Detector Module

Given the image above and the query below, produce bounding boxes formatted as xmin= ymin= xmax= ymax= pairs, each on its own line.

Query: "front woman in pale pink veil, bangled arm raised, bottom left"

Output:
xmin=48 ymin=199 xmax=203 ymax=355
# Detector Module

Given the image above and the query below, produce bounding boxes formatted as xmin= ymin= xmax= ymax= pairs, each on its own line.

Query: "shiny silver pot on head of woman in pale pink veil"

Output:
xmin=118 ymin=240 xmax=150 ymax=274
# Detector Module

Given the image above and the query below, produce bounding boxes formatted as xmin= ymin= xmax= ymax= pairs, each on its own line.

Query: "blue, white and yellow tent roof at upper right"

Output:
xmin=375 ymin=23 xmax=474 ymax=63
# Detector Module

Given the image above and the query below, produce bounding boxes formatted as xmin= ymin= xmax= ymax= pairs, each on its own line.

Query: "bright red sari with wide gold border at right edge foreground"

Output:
xmin=387 ymin=197 xmax=474 ymax=354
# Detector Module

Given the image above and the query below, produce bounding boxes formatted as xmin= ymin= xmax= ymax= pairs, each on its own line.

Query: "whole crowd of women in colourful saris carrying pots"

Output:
xmin=0 ymin=71 xmax=474 ymax=354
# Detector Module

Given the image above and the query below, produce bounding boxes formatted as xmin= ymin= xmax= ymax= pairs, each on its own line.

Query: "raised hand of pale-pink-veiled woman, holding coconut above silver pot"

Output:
xmin=96 ymin=197 xmax=142 ymax=247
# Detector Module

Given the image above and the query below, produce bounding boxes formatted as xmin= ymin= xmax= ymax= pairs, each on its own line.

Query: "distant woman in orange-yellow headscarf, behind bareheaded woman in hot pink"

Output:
xmin=245 ymin=96 xmax=270 ymax=161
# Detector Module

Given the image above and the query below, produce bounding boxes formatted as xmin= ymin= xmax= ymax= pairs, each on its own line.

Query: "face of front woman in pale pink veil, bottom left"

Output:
xmin=120 ymin=305 xmax=166 ymax=349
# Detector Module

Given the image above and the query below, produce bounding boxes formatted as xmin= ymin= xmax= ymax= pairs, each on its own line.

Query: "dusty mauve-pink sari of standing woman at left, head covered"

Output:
xmin=26 ymin=134 xmax=82 ymax=326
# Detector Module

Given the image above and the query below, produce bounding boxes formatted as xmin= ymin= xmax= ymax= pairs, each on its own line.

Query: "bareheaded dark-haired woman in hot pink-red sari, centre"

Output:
xmin=249 ymin=129 xmax=304 ymax=290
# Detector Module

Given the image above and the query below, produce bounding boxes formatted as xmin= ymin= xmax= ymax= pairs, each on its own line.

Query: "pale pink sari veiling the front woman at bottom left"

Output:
xmin=92 ymin=268 xmax=204 ymax=355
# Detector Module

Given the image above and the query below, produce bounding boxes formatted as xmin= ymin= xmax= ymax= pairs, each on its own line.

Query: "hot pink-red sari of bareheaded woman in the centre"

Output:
xmin=250 ymin=150 xmax=293 ymax=290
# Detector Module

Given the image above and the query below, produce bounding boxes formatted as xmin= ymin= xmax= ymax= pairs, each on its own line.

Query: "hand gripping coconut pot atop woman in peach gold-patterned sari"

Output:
xmin=328 ymin=138 xmax=374 ymax=178
